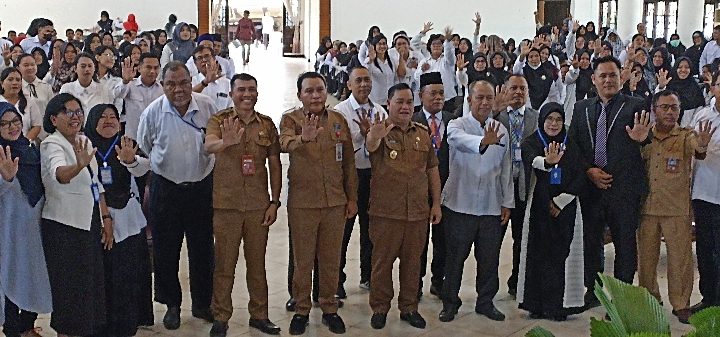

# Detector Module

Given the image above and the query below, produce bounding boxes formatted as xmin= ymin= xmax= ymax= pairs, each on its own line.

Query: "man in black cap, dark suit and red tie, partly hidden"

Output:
xmin=412 ymin=72 xmax=457 ymax=297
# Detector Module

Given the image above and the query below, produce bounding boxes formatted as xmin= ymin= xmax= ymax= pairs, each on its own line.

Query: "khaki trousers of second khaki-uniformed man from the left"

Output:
xmin=287 ymin=205 xmax=345 ymax=315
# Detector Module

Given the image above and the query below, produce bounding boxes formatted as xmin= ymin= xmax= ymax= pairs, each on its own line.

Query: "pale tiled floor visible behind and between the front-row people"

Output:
xmin=32 ymin=44 xmax=699 ymax=337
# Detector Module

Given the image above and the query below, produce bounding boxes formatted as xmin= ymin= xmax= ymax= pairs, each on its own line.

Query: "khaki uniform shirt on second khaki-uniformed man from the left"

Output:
xmin=280 ymin=108 xmax=357 ymax=208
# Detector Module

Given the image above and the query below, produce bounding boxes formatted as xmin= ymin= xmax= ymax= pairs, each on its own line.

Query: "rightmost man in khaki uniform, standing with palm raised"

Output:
xmin=638 ymin=90 xmax=714 ymax=324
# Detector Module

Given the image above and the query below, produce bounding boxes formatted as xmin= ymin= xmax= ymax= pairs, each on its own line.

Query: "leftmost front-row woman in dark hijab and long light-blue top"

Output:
xmin=0 ymin=102 xmax=52 ymax=337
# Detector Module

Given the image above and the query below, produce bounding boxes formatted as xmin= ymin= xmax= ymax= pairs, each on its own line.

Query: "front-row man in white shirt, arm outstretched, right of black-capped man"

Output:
xmin=440 ymin=81 xmax=515 ymax=322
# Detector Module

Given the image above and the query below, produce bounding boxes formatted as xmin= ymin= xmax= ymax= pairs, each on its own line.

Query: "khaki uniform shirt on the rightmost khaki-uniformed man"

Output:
xmin=642 ymin=126 xmax=698 ymax=216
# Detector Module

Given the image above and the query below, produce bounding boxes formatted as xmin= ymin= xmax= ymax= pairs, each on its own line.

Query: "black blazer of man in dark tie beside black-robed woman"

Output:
xmin=568 ymin=94 xmax=652 ymax=201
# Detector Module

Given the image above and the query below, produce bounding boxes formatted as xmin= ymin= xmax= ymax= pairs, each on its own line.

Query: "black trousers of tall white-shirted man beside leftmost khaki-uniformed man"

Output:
xmin=150 ymin=174 xmax=215 ymax=309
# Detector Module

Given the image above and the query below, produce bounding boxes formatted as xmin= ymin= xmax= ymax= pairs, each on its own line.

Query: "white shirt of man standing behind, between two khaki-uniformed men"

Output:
xmin=335 ymin=95 xmax=388 ymax=169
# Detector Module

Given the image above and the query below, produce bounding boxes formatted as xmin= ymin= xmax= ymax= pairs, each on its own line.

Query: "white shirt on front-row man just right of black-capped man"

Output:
xmin=441 ymin=114 xmax=515 ymax=216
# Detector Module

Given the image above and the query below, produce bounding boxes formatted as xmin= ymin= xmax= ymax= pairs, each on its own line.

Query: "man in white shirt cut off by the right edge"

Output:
xmin=691 ymin=71 xmax=720 ymax=312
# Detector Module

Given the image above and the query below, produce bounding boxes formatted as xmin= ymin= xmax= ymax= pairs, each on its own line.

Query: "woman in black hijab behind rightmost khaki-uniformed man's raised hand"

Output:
xmin=655 ymin=56 xmax=705 ymax=127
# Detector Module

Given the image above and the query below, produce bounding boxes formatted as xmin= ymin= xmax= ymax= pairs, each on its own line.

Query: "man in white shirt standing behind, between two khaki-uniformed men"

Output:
xmin=335 ymin=66 xmax=387 ymax=298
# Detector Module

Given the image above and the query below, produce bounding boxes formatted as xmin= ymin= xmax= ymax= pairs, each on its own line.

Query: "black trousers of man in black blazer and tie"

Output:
xmin=580 ymin=188 xmax=641 ymax=298
